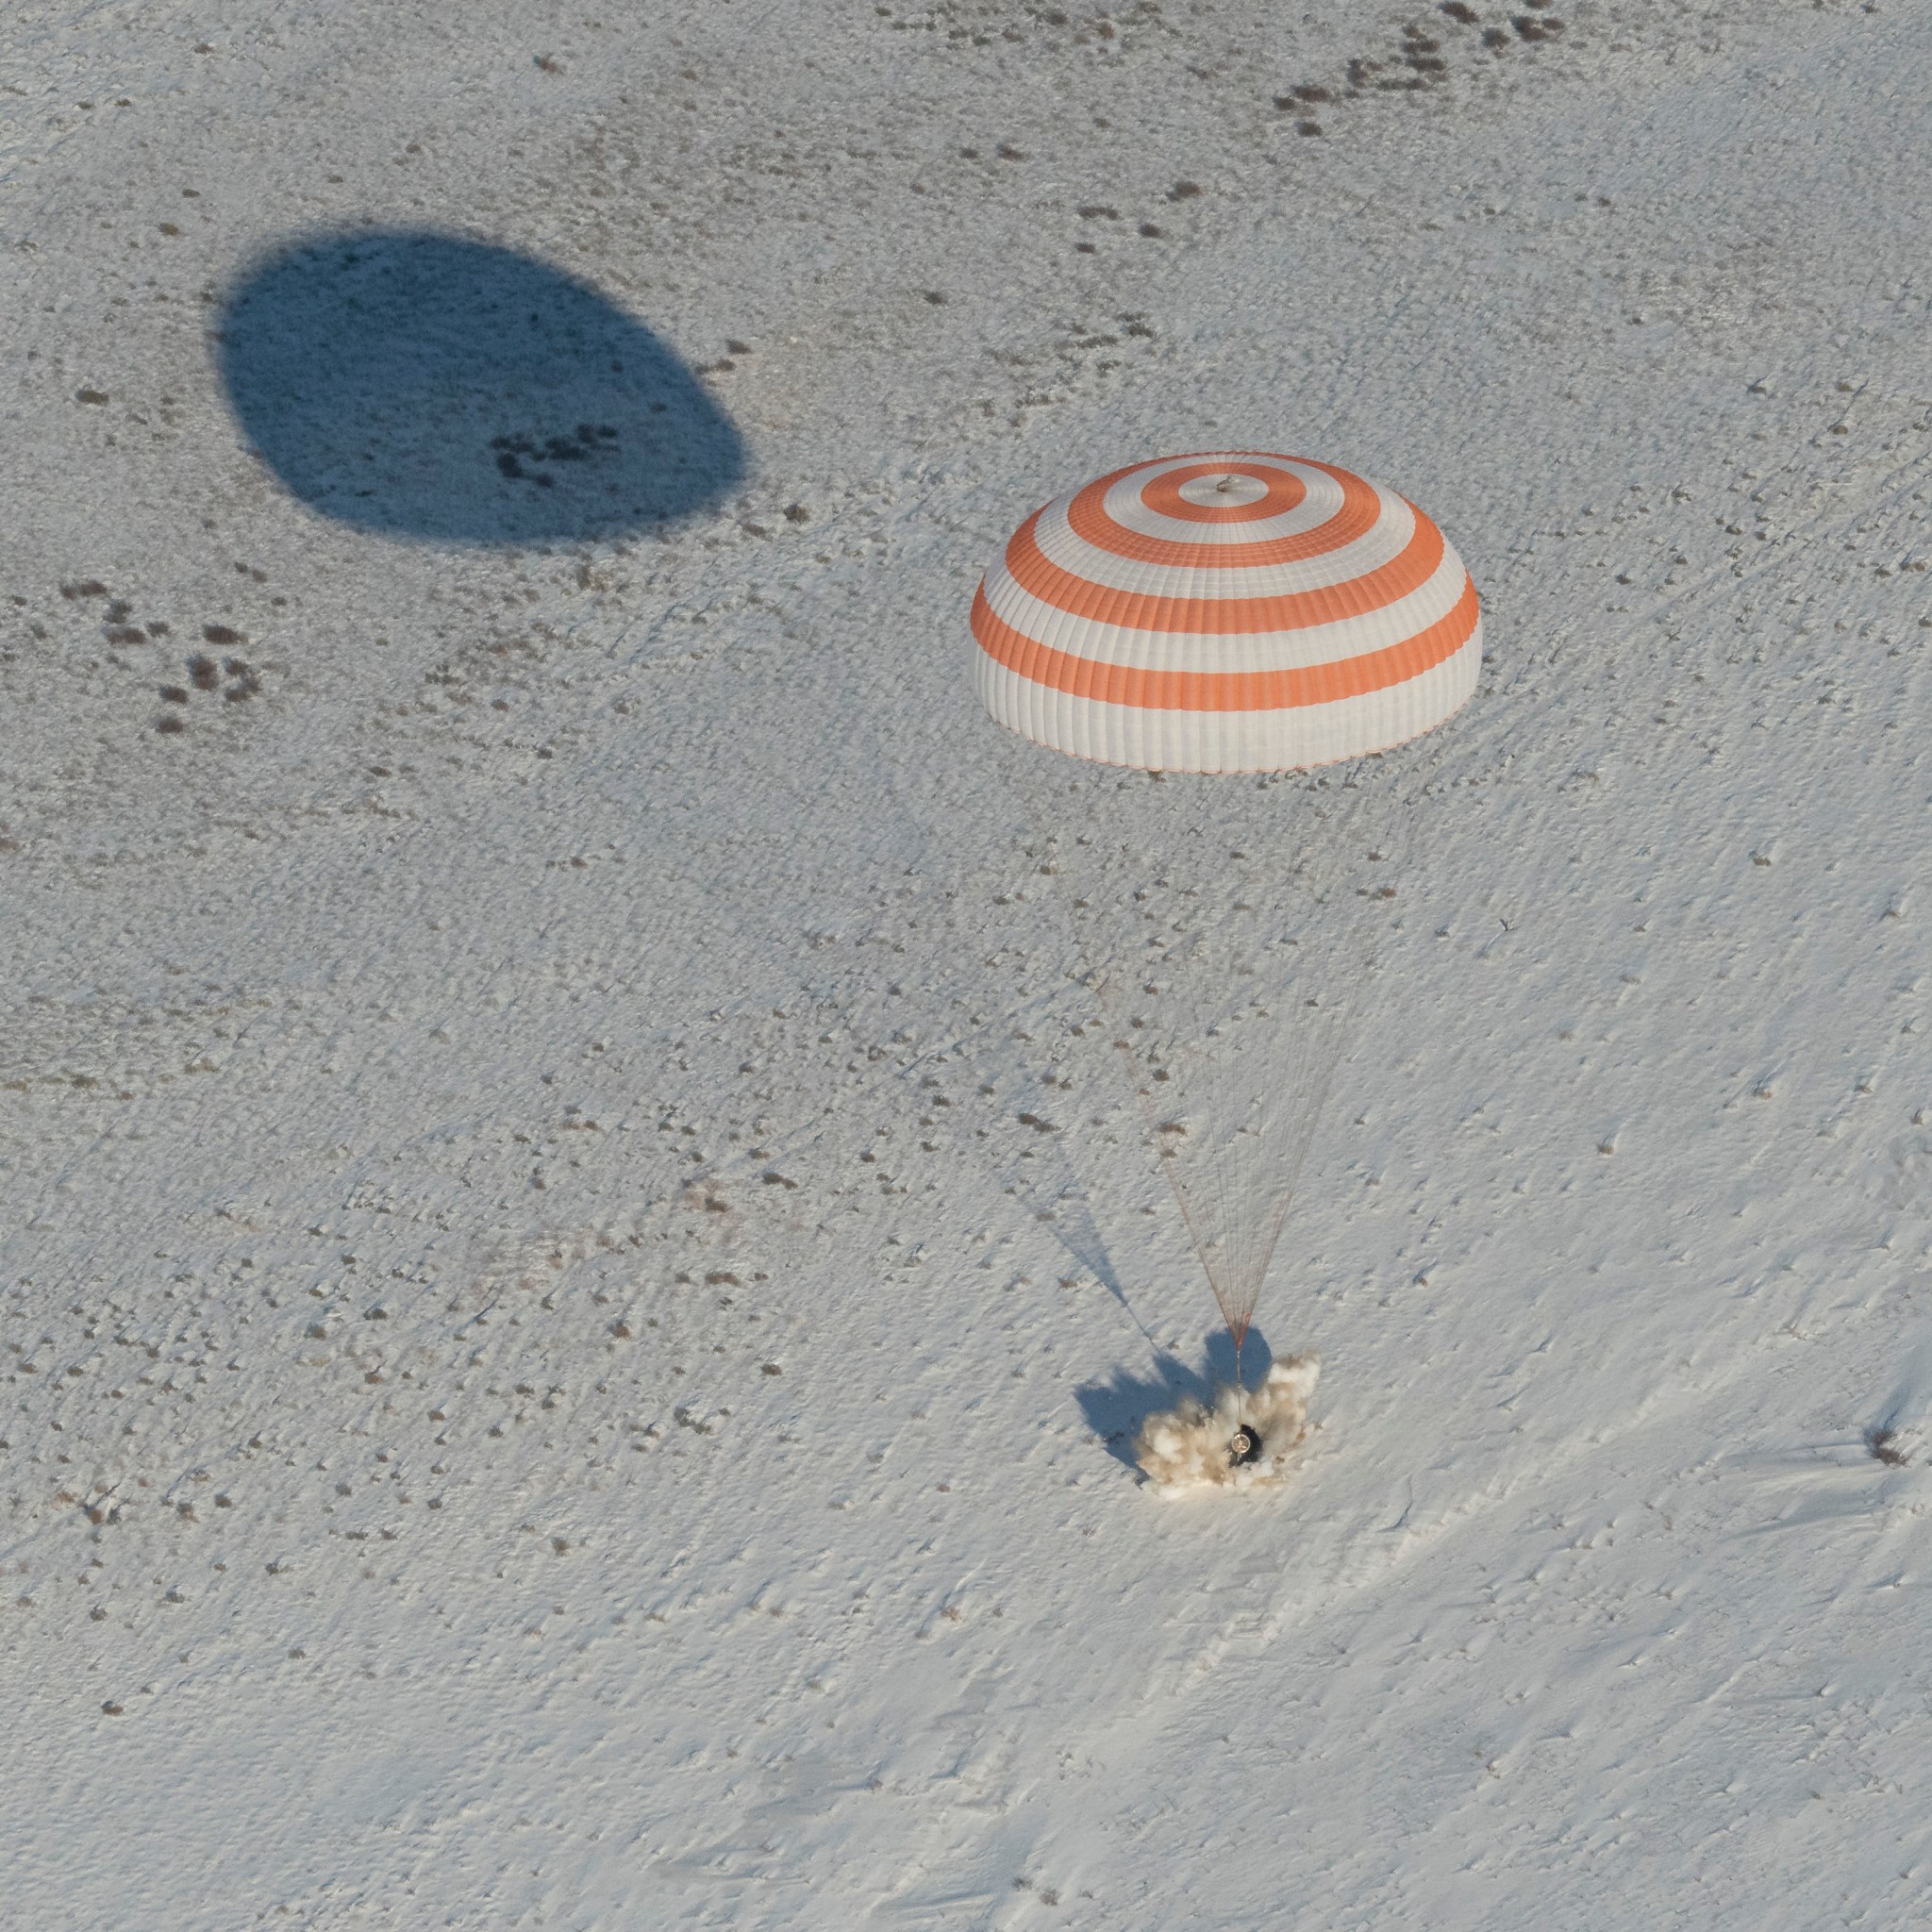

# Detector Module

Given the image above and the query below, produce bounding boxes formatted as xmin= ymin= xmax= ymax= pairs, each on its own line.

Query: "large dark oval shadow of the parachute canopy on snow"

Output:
xmin=218 ymin=228 xmax=746 ymax=545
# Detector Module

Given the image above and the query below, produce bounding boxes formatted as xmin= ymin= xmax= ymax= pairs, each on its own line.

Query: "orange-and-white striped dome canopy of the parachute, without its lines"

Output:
xmin=972 ymin=450 xmax=1482 ymax=771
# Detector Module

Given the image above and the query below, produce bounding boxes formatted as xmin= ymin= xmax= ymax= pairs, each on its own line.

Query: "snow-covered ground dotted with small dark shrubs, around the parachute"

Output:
xmin=0 ymin=0 xmax=1932 ymax=1932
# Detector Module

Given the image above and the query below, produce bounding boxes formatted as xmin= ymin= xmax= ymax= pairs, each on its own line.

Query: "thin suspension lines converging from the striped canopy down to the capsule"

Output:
xmin=1032 ymin=774 xmax=1403 ymax=1464
